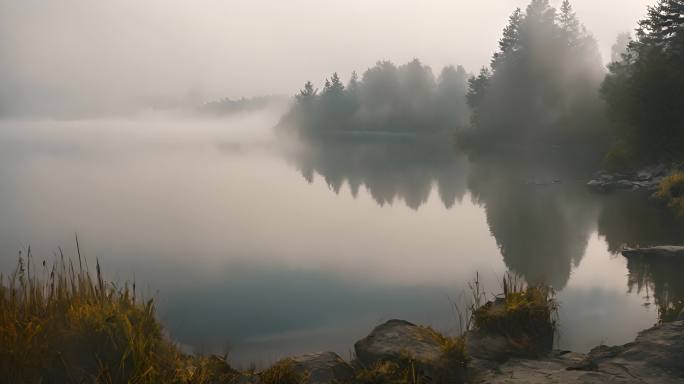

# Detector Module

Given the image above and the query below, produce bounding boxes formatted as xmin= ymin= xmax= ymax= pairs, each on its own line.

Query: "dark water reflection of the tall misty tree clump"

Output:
xmin=469 ymin=154 xmax=598 ymax=289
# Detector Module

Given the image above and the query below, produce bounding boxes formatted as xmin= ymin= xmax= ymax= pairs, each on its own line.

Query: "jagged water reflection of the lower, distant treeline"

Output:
xmin=289 ymin=135 xmax=468 ymax=209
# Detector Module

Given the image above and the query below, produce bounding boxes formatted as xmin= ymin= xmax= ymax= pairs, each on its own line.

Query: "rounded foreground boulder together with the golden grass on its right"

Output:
xmin=354 ymin=320 xmax=465 ymax=382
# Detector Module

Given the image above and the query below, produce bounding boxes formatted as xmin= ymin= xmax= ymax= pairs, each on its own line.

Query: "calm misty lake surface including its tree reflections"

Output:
xmin=0 ymin=112 xmax=684 ymax=367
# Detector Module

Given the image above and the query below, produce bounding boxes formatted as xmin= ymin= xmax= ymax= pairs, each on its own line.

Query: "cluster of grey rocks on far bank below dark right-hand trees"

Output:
xmin=587 ymin=164 xmax=673 ymax=192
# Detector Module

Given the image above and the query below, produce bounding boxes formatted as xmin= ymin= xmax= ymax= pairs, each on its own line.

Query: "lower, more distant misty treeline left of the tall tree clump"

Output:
xmin=280 ymin=59 xmax=469 ymax=135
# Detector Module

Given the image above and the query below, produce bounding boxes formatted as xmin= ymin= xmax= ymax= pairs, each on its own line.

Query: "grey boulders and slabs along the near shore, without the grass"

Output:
xmin=222 ymin=314 xmax=684 ymax=384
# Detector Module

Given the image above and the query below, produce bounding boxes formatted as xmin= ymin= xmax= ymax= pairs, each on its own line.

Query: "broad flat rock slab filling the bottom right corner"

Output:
xmin=475 ymin=321 xmax=684 ymax=384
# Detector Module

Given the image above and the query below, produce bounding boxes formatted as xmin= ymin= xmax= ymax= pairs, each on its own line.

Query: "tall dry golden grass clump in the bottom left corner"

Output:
xmin=0 ymin=249 xmax=185 ymax=384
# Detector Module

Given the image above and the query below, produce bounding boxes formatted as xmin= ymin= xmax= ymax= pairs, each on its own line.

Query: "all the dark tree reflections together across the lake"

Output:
xmin=280 ymin=134 xmax=684 ymax=296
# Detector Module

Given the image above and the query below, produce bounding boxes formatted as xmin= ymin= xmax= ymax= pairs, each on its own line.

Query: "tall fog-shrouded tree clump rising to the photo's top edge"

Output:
xmin=468 ymin=0 xmax=605 ymax=144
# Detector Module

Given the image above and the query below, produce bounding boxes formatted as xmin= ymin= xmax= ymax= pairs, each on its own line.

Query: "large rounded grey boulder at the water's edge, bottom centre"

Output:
xmin=354 ymin=320 xmax=443 ymax=377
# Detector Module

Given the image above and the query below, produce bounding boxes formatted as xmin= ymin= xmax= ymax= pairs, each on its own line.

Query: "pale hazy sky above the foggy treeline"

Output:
xmin=0 ymin=0 xmax=655 ymax=115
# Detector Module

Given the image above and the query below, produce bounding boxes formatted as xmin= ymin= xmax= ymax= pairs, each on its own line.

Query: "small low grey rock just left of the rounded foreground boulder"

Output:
xmin=292 ymin=352 xmax=354 ymax=384
